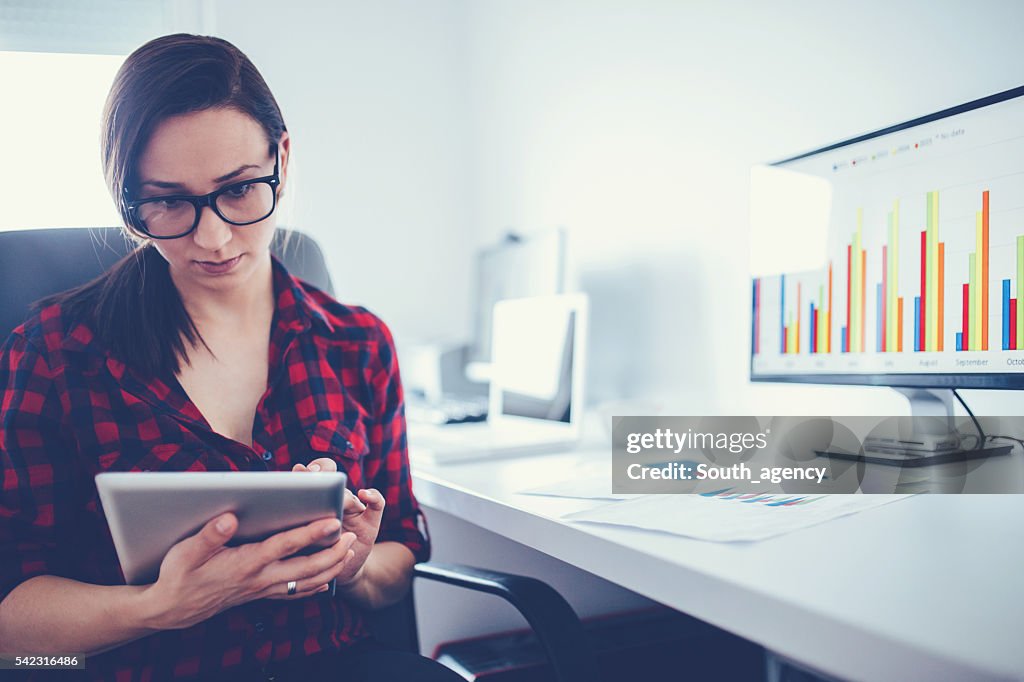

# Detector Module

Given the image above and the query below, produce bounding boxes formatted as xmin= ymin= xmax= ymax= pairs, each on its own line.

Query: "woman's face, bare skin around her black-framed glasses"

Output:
xmin=138 ymin=109 xmax=289 ymax=293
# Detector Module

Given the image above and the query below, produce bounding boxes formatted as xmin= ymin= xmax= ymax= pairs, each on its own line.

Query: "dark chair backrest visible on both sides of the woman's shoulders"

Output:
xmin=0 ymin=227 xmax=334 ymax=341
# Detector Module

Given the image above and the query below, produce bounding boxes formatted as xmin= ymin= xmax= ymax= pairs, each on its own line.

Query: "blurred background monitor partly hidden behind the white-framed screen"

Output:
xmin=468 ymin=227 xmax=566 ymax=364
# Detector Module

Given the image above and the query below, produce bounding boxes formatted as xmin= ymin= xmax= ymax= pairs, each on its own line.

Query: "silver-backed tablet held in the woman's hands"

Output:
xmin=96 ymin=471 xmax=346 ymax=585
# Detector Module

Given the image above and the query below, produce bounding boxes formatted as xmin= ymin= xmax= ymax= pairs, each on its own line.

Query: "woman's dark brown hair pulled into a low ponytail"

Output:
xmin=36 ymin=34 xmax=287 ymax=378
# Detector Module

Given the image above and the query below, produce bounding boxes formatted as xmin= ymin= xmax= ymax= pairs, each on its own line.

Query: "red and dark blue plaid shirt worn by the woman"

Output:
xmin=0 ymin=253 xmax=429 ymax=680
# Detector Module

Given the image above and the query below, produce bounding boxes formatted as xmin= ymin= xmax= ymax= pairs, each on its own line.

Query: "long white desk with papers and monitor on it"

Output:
xmin=414 ymin=453 xmax=1024 ymax=681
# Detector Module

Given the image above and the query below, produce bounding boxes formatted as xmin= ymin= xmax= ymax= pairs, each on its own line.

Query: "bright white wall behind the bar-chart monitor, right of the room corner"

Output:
xmin=466 ymin=0 xmax=1024 ymax=414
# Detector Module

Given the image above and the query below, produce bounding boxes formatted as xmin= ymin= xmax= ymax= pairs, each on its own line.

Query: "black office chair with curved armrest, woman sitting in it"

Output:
xmin=0 ymin=227 xmax=600 ymax=682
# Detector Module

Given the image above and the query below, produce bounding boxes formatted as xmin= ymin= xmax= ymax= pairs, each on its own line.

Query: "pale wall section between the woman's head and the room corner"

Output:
xmin=210 ymin=0 xmax=474 ymax=339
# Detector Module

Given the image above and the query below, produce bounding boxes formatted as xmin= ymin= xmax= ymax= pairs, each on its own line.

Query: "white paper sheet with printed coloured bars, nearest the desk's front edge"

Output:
xmin=562 ymin=495 xmax=910 ymax=542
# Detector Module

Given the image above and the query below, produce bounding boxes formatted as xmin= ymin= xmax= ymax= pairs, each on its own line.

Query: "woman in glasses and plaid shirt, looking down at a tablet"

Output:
xmin=0 ymin=35 xmax=460 ymax=680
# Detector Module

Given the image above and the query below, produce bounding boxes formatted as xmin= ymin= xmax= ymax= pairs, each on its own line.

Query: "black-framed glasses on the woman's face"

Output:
xmin=124 ymin=146 xmax=281 ymax=240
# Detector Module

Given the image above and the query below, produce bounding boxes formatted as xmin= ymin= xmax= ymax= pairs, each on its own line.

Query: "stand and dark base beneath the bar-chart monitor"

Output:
xmin=819 ymin=387 xmax=1013 ymax=467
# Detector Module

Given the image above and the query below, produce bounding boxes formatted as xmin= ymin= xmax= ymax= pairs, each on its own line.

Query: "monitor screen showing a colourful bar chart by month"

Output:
xmin=751 ymin=87 xmax=1024 ymax=388
